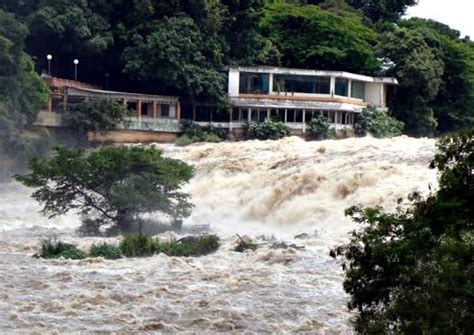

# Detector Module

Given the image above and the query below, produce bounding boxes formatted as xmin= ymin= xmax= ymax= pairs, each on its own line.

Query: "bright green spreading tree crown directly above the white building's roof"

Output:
xmin=262 ymin=4 xmax=379 ymax=74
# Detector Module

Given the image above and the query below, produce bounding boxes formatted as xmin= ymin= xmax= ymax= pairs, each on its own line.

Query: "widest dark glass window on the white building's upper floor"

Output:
xmin=273 ymin=74 xmax=331 ymax=94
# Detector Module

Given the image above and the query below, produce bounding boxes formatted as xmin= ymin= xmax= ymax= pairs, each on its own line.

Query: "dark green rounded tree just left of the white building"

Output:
xmin=123 ymin=16 xmax=225 ymax=101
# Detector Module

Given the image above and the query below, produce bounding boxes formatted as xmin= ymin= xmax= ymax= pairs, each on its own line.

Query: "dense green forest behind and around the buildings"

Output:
xmin=0 ymin=0 xmax=474 ymax=161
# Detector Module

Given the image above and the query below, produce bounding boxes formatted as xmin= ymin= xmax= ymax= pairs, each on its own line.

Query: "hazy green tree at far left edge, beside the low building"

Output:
xmin=0 ymin=10 xmax=48 ymax=175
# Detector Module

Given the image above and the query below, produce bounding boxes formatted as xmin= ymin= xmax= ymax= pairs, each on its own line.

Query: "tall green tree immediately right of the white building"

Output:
xmin=379 ymin=27 xmax=444 ymax=136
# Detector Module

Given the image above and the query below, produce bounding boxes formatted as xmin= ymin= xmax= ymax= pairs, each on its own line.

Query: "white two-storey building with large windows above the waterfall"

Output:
xmin=228 ymin=67 xmax=398 ymax=133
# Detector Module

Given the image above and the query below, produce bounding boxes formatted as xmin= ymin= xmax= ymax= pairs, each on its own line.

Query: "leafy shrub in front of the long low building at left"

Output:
xmin=62 ymin=100 xmax=128 ymax=135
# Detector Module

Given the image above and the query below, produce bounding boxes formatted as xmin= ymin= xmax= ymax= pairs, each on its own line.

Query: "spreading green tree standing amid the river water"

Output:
xmin=16 ymin=146 xmax=193 ymax=232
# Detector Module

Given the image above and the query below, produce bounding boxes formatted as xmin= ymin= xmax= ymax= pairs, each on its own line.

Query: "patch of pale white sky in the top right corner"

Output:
xmin=407 ymin=0 xmax=474 ymax=40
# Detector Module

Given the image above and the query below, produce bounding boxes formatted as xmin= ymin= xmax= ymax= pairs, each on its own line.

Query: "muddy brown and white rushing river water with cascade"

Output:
xmin=0 ymin=137 xmax=436 ymax=334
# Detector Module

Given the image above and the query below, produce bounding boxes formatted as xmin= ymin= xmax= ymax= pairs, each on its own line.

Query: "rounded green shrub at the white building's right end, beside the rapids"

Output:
xmin=354 ymin=108 xmax=404 ymax=138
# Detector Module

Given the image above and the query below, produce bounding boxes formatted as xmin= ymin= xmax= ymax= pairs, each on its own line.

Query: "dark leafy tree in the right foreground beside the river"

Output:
xmin=332 ymin=130 xmax=474 ymax=334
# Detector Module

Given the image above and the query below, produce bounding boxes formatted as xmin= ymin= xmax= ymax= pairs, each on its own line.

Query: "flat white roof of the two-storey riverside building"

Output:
xmin=228 ymin=66 xmax=398 ymax=85
